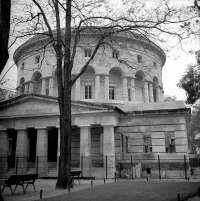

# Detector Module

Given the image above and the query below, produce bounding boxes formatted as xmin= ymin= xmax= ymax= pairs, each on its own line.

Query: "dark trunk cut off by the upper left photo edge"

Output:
xmin=0 ymin=0 xmax=11 ymax=73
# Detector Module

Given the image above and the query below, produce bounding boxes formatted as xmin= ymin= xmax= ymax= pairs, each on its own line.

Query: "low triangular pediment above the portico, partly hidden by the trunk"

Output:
xmin=0 ymin=94 xmax=114 ymax=117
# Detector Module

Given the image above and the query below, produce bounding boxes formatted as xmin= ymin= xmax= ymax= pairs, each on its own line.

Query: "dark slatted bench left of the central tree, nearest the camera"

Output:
xmin=1 ymin=174 xmax=39 ymax=195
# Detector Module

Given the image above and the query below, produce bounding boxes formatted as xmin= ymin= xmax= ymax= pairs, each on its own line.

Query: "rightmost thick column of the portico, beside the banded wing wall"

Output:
xmin=103 ymin=125 xmax=116 ymax=178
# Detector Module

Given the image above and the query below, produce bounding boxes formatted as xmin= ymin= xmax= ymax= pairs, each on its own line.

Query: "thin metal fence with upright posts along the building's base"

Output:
xmin=0 ymin=155 xmax=191 ymax=179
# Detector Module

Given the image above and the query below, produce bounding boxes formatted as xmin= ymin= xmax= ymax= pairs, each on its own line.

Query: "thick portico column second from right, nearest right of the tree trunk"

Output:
xmin=79 ymin=125 xmax=91 ymax=177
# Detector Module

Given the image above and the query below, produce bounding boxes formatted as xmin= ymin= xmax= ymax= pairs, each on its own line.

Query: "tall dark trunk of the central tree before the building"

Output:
xmin=56 ymin=0 xmax=73 ymax=189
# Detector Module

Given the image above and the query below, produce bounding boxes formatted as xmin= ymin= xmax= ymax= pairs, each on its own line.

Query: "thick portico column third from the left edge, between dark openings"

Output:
xmin=36 ymin=128 xmax=48 ymax=176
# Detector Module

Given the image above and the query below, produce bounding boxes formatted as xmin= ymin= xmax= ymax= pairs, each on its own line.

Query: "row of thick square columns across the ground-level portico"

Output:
xmin=0 ymin=124 xmax=115 ymax=178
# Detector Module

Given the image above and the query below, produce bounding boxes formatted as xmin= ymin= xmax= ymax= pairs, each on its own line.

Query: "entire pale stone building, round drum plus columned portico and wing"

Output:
xmin=0 ymin=29 xmax=190 ymax=178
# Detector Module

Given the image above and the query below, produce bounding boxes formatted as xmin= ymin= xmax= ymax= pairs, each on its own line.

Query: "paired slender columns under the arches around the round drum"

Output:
xmin=17 ymin=74 xmax=163 ymax=103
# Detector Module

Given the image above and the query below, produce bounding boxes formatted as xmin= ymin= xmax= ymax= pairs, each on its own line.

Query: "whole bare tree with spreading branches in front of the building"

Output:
xmin=10 ymin=0 xmax=194 ymax=189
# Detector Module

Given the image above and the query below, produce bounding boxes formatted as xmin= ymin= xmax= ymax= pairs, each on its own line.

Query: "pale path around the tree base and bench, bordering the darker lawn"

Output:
xmin=3 ymin=179 xmax=200 ymax=201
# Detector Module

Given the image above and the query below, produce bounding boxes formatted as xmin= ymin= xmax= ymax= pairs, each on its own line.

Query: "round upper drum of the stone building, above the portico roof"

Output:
xmin=14 ymin=32 xmax=166 ymax=103
